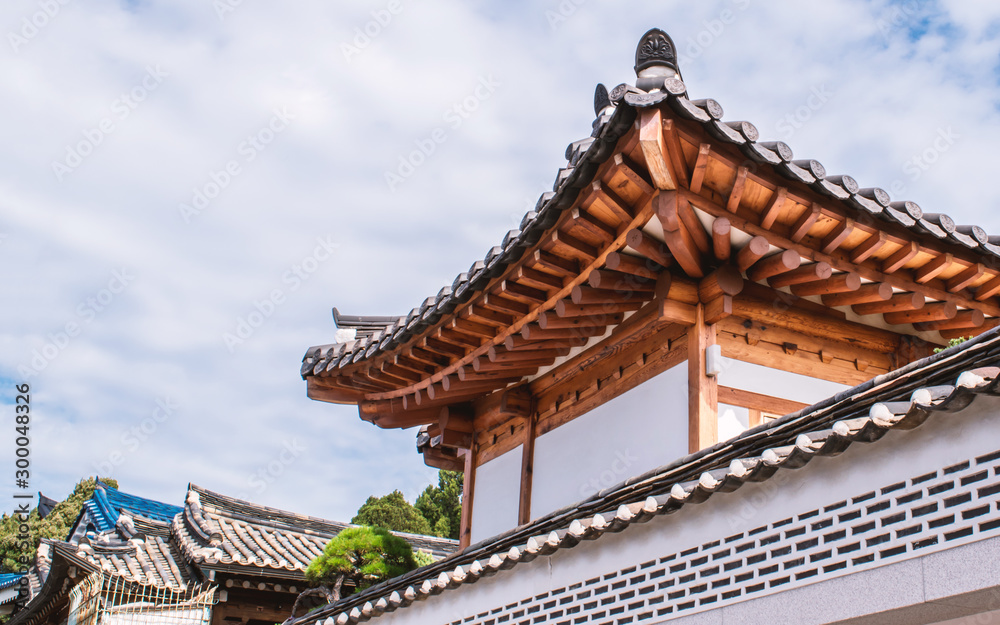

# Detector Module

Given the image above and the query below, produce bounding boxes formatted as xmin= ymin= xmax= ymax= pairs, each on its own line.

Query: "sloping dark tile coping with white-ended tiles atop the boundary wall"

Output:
xmin=294 ymin=330 xmax=1000 ymax=625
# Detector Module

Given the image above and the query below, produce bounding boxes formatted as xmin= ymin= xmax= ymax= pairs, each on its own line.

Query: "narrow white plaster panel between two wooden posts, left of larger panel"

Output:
xmin=472 ymin=445 xmax=521 ymax=544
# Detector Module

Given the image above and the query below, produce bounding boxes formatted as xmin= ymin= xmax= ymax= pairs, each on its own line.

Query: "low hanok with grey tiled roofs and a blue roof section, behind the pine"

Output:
xmin=13 ymin=485 xmax=457 ymax=625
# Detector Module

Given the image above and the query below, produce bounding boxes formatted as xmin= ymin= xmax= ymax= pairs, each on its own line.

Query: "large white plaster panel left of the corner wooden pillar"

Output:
xmin=531 ymin=362 xmax=688 ymax=518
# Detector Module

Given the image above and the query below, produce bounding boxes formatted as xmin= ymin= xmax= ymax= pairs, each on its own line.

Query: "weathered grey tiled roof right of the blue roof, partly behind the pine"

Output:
xmin=172 ymin=484 xmax=458 ymax=578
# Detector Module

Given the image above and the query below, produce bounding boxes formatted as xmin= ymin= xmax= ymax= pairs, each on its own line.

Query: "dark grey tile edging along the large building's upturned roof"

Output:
xmin=300 ymin=59 xmax=1000 ymax=379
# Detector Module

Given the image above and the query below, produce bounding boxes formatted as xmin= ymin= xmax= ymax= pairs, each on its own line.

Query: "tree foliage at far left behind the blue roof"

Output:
xmin=0 ymin=477 xmax=118 ymax=573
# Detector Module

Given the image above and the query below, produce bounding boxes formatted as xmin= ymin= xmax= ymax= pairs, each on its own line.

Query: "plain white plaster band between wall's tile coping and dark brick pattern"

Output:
xmin=364 ymin=397 xmax=1000 ymax=625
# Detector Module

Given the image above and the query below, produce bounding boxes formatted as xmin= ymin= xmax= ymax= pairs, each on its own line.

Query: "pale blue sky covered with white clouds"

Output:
xmin=0 ymin=0 xmax=1000 ymax=520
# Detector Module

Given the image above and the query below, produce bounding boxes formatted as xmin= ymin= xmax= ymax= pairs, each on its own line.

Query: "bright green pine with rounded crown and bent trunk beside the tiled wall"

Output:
xmin=292 ymin=528 xmax=417 ymax=617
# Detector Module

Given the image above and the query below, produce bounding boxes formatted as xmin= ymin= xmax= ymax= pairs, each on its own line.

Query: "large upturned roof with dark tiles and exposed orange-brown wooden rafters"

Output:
xmin=300 ymin=30 xmax=1000 ymax=427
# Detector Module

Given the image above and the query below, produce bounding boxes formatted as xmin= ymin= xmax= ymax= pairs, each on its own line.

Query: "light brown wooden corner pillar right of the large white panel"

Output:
xmin=688 ymin=304 xmax=719 ymax=453
